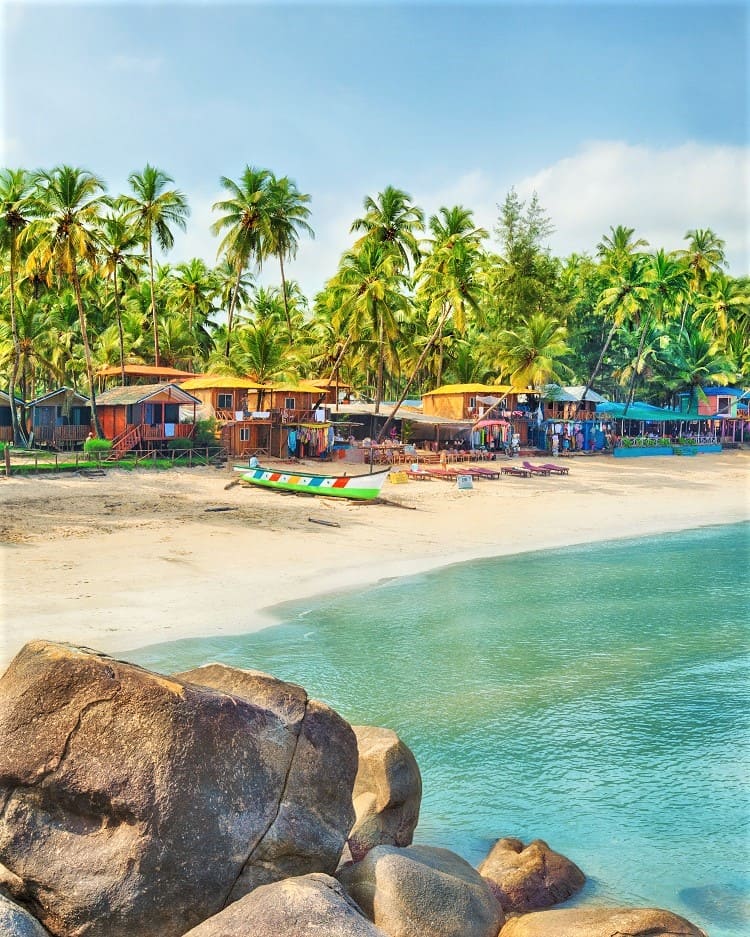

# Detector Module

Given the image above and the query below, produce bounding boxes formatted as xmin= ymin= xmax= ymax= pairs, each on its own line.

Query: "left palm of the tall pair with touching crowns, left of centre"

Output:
xmin=211 ymin=166 xmax=273 ymax=358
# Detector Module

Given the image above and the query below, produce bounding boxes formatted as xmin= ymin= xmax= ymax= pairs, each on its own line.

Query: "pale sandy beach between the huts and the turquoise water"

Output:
xmin=0 ymin=451 xmax=750 ymax=666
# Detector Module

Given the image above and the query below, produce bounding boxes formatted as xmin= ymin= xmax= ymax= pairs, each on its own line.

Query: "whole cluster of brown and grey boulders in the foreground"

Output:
xmin=0 ymin=641 xmax=702 ymax=937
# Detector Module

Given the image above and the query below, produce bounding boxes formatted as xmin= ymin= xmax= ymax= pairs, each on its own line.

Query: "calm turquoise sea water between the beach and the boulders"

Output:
xmin=129 ymin=524 xmax=750 ymax=937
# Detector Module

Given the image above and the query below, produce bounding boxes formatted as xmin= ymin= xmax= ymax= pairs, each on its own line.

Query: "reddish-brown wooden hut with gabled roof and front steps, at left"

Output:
xmin=96 ymin=384 xmax=201 ymax=454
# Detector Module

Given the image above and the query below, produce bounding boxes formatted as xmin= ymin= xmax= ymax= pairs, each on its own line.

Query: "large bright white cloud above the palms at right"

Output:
xmin=516 ymin=141 xmax=750 ymax=276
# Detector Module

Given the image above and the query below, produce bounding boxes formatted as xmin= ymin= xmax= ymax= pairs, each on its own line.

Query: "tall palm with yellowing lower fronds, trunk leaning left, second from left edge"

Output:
xmin=24 ymin=166 xmax=104 ymax=436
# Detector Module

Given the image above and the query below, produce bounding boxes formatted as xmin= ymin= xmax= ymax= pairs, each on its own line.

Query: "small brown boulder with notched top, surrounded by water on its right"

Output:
xmin=479 ymin=837 xmax=586 ymax=911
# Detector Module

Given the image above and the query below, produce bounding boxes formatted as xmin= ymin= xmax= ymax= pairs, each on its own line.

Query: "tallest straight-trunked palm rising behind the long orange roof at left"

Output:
xmin=120 ymin=163 xmax=190 ymax=368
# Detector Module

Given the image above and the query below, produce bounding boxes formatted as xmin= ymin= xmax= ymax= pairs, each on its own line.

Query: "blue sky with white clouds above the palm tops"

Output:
xmin=0 ymin=0 xmax=750 ymax=296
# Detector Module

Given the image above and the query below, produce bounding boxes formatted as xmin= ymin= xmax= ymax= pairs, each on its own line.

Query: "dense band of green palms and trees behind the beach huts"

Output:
xmin=0 ymin=165 xmax=750 ymax=441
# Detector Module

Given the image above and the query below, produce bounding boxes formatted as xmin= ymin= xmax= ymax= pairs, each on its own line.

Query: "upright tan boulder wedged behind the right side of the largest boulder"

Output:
xmin=349 ymin=726 xmax=422 ymax=861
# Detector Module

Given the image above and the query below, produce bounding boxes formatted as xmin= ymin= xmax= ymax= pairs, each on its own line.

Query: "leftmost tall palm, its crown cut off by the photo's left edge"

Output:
xmin=0 ymin=169 xmax=35 ymax=445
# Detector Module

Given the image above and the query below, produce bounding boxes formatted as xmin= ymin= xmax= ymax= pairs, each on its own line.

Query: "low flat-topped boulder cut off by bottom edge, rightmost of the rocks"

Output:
xmin=500 ymin=908 xmax=706 ymax=937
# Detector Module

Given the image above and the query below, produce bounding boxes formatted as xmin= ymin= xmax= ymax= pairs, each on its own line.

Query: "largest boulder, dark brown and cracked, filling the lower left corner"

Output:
xmin=0 ymin=641 xmax=357 ymax=937
